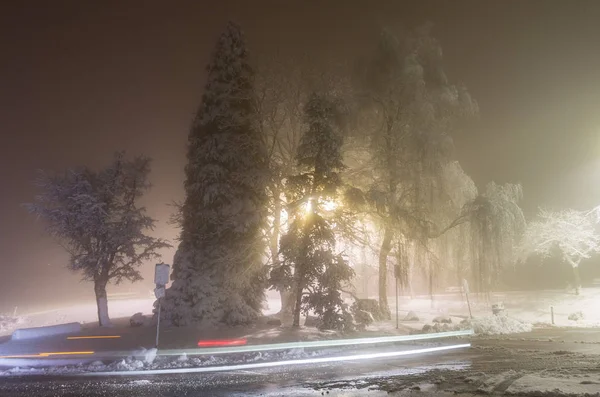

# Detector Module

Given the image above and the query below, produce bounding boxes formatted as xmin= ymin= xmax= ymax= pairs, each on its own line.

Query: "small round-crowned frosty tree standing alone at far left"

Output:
xmin=26 ymin=153 xmax=169 ymax=326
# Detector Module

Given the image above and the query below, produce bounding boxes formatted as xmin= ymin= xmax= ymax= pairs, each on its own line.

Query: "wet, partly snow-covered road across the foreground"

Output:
xmin=0 ymin=329 xmax=600 ymax=397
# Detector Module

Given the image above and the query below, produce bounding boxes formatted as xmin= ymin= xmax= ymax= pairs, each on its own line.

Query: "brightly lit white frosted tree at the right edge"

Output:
xmin=519 ymin=209 xmax=600 ymax=294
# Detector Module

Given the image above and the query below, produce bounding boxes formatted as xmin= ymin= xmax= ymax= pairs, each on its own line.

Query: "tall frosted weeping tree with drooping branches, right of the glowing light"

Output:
xmin=357 ymin=26 xmax=477 ymax=315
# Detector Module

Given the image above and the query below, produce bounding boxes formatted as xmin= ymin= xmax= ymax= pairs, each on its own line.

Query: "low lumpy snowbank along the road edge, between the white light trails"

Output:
xmin=0 ymin=349 xmax=331 ymax=377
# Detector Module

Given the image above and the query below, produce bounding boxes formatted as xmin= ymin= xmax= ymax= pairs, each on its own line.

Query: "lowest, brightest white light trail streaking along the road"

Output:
xmin=77 ymin=343 xmax=471 ymax=376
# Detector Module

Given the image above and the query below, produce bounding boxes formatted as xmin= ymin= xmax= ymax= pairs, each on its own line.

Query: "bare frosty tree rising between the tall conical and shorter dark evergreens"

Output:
xmin=255 ymin=55 xmax=352 ymax=314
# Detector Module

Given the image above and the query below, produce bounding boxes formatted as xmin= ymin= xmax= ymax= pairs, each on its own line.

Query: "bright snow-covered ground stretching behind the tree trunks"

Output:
xmin=0 ymin=288 xmax=600 ymax=340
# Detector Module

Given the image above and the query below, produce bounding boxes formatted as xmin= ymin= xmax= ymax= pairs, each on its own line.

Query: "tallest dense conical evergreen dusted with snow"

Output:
xmin=163 ymin=23 xmax=268 ymax=325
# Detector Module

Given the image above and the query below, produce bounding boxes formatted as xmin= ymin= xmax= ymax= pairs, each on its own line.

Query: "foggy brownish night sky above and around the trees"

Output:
xmin=0 ymin=0 xmax=600 ymax=312
